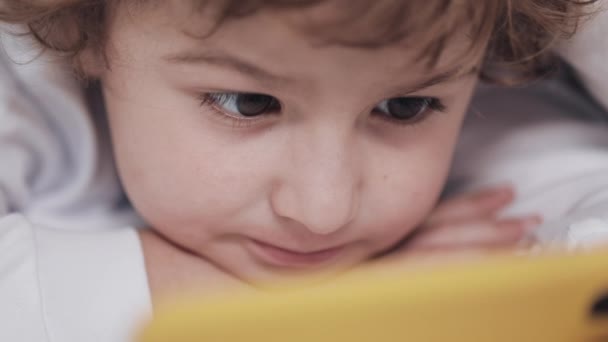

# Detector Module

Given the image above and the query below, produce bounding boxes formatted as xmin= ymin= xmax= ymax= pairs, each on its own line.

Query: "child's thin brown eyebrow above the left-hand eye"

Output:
xmin=163 ymin=51 xmax=293 ymax=87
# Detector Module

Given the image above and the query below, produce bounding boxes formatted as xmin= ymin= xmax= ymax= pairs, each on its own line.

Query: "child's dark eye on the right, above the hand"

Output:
xmin=374 ymin=97 xmax=445 ymax=123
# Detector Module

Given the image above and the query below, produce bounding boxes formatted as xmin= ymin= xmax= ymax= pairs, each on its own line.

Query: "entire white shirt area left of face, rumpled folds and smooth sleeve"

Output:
xmin=0 ymin=27 xmax=152 ymax=342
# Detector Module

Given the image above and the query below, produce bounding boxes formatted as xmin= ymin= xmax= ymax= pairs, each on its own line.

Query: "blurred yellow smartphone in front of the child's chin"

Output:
xmin=138 ymin=252 xmax=608 ymax=342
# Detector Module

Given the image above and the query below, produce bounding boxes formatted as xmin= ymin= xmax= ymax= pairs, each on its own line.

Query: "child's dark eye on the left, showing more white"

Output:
xmin=203 ymin=93 xmax=281 ymax=118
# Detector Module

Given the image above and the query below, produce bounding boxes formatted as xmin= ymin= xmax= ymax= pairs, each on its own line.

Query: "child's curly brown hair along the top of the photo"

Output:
xmin=0 ymin=0 xmax=596 ymax=83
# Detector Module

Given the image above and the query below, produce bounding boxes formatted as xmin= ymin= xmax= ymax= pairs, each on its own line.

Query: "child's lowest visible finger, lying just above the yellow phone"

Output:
xmin=406 ymin=216 xmax=541 ymax=251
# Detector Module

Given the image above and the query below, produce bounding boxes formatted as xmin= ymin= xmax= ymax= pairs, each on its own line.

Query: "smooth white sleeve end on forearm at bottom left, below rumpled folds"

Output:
xmin=0 ymin=215 xmax=151 ymax=342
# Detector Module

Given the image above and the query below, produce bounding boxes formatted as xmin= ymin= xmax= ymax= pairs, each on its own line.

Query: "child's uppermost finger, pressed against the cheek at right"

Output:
xmin=427 ymin=186 xmax=515 ymax=225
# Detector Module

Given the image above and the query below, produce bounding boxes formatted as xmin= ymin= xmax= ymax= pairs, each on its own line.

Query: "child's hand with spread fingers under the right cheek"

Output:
xmin=397 ymin=187 xmax=541 ymax=255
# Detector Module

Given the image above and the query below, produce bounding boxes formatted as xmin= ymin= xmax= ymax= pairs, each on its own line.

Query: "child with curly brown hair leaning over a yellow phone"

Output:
xmin=0 ymin=0 xmax=584 ymax=341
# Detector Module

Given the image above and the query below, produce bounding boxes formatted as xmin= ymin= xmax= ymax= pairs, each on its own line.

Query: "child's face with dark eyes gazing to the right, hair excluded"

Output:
xmin=99 ymin=2 xmax=476 ymax=281
